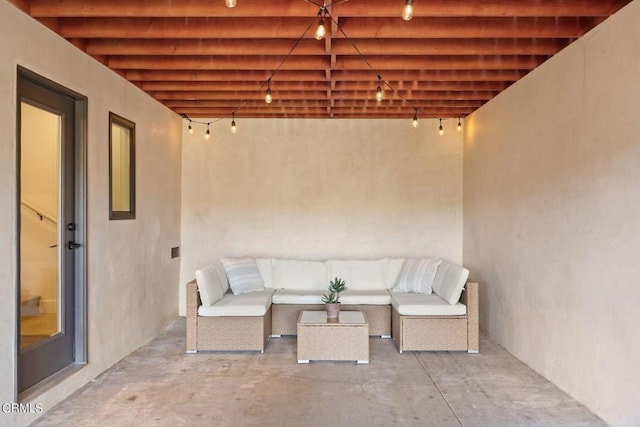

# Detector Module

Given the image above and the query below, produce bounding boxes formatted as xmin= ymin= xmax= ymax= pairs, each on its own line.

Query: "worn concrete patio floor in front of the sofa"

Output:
xmin=34 ymin=319 xmax=605 ymax=427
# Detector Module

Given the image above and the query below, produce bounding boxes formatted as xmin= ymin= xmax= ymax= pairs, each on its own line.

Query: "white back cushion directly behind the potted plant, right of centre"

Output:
xmin=327 ymin=259 xmax=387 ymax=291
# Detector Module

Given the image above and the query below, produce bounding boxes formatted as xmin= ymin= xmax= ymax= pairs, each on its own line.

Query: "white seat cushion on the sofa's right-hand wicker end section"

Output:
xmin=391 ymin=292 xmax=467 ymax=316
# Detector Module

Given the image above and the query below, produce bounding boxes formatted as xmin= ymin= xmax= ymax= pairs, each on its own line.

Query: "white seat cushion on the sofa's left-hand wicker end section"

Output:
xmin=198 ymin=289 xmax=273 ymax=317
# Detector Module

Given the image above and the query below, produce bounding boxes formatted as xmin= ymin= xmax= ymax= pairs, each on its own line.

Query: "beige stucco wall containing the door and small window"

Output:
xmin=0 ymin=1 xmax=182 ymax=425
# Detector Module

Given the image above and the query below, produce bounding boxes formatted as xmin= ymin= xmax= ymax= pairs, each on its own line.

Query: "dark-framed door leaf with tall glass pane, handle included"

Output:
xmin=18 ymin=78 xmax=77 ymax=391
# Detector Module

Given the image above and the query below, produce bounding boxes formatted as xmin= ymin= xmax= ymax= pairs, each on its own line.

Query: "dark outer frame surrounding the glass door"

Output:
xmin=13 ymin=66 xmax=88 ymax=402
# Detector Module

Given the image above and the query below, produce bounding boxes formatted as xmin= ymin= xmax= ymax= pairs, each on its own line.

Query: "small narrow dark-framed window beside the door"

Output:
xmin=109 ymin=113 xmax=136 ymax=219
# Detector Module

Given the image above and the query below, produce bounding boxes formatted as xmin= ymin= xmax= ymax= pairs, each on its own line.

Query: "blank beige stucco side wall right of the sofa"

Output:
xmin=464 ymin=1 xmax=640 ymax=426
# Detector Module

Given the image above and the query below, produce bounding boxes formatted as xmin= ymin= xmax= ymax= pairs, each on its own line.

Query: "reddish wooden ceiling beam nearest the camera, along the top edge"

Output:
xmin=27 ymin=0 xmax=620 ymax=17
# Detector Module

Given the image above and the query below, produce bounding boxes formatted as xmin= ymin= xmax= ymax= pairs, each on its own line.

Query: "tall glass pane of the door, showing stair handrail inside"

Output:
xmin=20 ymin=102 xmax=62 ymax=349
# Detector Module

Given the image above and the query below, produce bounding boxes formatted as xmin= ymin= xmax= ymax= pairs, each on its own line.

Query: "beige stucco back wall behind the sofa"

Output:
xmin=180 ymin=117 xmax=462 ymax=313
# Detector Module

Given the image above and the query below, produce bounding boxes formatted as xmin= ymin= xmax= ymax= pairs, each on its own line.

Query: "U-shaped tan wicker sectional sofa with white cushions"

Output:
xmin=186 ymin=258 xmax=478 ymax=353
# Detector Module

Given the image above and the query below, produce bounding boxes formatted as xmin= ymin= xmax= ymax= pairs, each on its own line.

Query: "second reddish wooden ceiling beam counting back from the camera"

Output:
xmin=58 ymin=17 xmax=593 ymax=39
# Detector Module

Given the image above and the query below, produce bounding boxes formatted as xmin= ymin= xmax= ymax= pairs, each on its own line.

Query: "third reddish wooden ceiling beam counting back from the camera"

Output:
xmin=85 ymin=38 xmax=571 ymax=56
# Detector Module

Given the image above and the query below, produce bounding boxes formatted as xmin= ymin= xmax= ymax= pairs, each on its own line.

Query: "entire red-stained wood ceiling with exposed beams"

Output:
xmin=11 ymin=0 xmax=630 ymax=119
